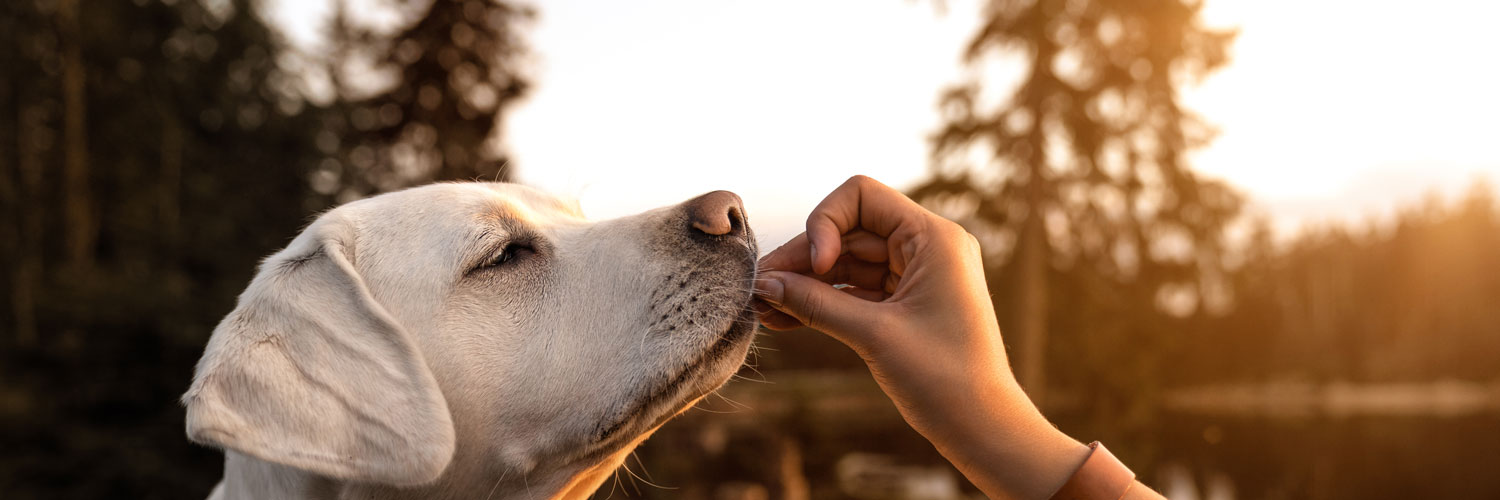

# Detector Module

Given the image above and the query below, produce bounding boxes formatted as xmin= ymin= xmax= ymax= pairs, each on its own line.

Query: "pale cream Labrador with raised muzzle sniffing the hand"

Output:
xmin=183 ymin=183 xmax=756 ymax=498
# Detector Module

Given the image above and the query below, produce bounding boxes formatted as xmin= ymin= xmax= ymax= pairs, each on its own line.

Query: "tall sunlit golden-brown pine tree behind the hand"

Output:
xmin=912 ymin=0 xmax=1239 ymax=401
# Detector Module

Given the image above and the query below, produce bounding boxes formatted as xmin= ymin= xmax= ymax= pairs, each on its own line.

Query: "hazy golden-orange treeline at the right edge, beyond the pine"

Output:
xmin=1167 ymin=183 xmax=1500 ymax=384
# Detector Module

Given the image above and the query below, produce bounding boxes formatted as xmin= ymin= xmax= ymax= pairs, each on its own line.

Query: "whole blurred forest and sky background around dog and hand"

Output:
xmin=0 ymin=0 xmax=1500 ymax=500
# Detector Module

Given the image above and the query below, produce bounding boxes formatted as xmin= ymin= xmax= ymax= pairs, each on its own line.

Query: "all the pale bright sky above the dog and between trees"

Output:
xmin=270 ymin=0 xmax=1500 ymax=248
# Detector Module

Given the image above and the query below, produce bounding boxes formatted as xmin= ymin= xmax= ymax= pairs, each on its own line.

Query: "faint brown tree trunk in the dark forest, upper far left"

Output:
xmin=57 ymin=0 xmax=98 ymax=270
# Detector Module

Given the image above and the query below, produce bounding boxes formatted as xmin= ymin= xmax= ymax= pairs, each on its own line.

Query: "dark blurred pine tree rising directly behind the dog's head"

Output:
xmin=330 ymin=0 xmax=534 ymax=198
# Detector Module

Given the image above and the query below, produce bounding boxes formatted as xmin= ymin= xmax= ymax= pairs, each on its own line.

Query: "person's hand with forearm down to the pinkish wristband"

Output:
xmin=756 ymin=176 xmax=1089 ymax=498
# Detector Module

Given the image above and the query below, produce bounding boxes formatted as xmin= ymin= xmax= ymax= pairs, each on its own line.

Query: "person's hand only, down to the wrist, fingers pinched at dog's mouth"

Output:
xmin=758 ymin=176 xmax=1025 ymax=431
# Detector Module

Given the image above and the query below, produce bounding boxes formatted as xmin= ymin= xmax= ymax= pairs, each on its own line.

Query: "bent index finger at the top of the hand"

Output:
xmin=807 ymin=176 xmax=926 ymax=273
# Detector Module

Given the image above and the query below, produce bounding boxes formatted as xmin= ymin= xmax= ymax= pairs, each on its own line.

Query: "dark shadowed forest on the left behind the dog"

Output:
xmin=0 ymin=0 xmax=533 ymax=498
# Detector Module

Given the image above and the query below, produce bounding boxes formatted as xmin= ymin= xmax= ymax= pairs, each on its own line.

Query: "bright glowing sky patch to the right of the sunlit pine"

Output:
xmin=1184 ymin=0 xmax=1500 ymax=218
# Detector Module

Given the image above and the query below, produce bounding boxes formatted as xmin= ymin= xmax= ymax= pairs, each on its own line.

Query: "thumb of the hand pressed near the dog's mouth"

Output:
xmin=756 ymin=270 xmax=878 ymax=345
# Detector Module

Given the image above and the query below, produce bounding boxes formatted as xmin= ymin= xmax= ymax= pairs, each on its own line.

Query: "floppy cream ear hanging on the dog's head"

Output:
xmin=183 ymin=215 xmax=455 ymax=485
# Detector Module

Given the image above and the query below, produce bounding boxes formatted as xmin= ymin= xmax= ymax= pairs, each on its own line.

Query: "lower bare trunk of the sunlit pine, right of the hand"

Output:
xmin=1014 ymin=204 xmax=1049 ymax=407
